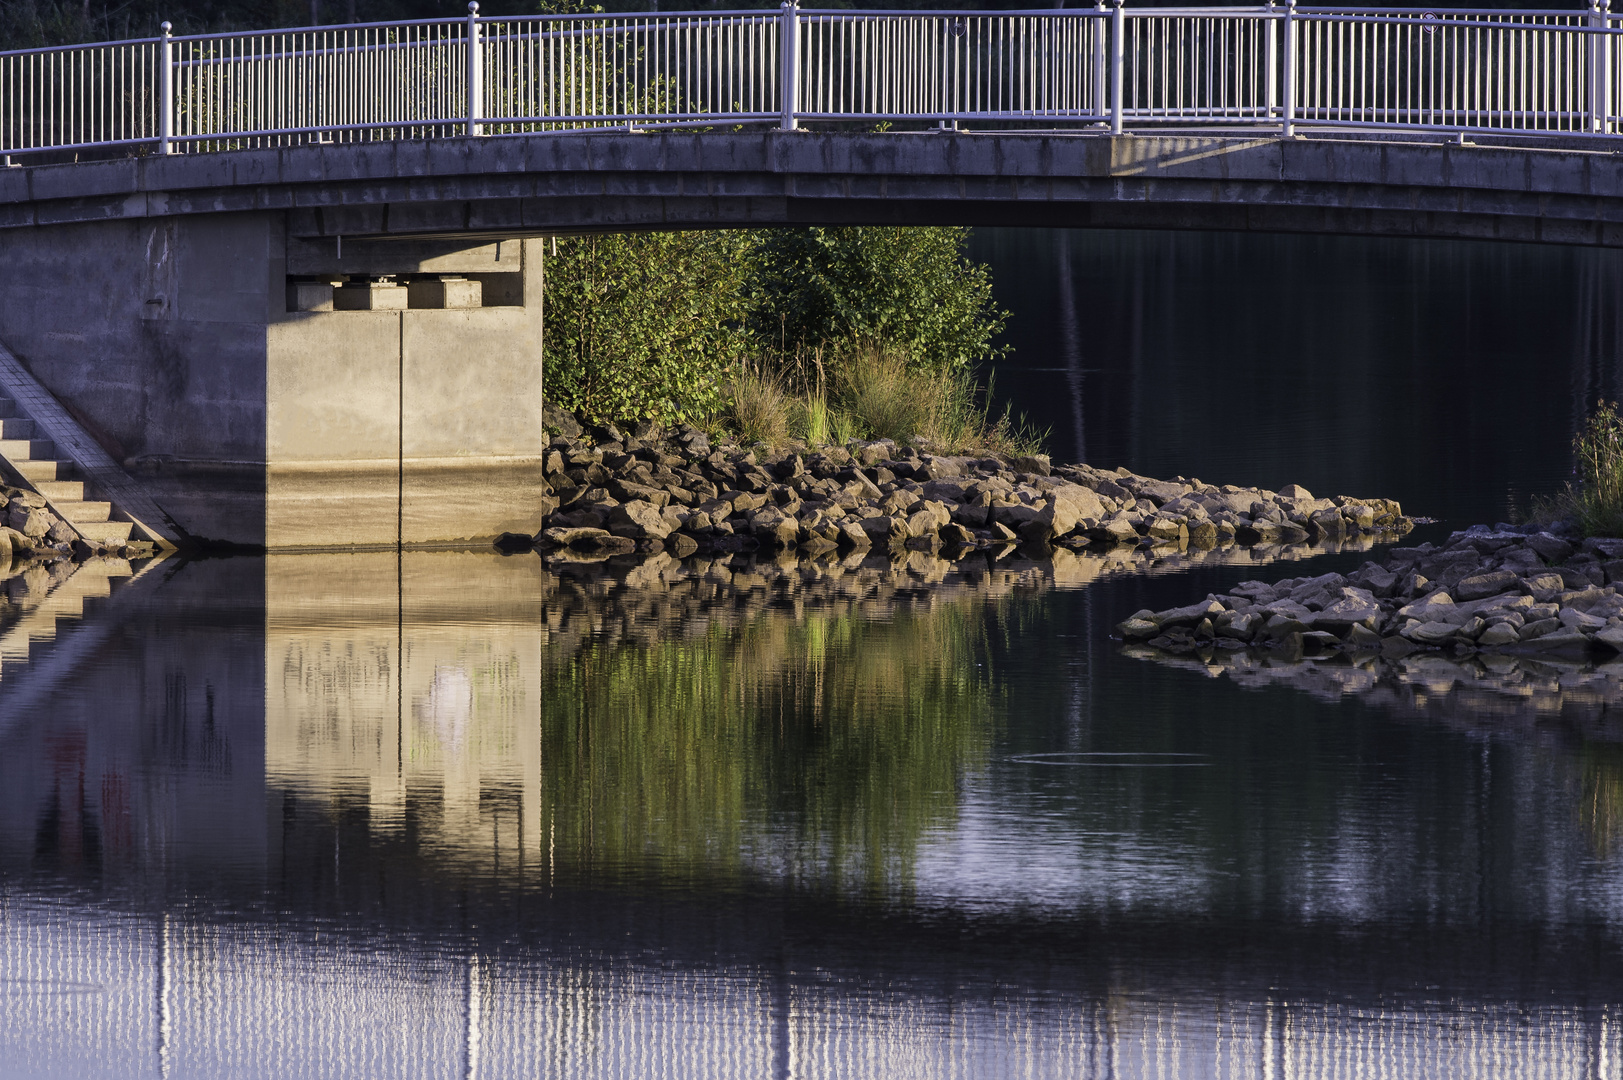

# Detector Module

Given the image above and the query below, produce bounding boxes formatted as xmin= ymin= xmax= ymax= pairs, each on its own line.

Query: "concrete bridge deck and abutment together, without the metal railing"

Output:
xmin=0 ymin=130 xmax=1623 ymax=549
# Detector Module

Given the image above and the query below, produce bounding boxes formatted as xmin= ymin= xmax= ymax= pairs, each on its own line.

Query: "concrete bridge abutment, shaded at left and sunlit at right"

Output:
xmin=0 ymin=211 xmax=547 ymax=549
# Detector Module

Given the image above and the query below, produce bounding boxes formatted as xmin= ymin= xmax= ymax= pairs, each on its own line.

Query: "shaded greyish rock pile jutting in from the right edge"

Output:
xmin=1117 ymin=525 xmax=1623 ymax=659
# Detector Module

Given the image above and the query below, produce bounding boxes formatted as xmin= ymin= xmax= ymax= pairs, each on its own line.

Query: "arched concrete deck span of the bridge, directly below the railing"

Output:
xmin=0 ymin=130 xmax=1623 ymax=247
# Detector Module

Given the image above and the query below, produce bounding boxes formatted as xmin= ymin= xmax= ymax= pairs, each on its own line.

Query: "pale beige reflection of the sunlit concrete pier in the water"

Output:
xmin=265 ymin=552 xmax=552 ymax=861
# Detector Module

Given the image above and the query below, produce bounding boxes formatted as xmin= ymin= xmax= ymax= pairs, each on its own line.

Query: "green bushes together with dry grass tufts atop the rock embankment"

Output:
xmin=544 ymin=227 xmax=1032 ymax=448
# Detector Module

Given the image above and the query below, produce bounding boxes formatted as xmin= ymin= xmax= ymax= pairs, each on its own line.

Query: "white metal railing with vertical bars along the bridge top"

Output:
xmin=0 ymin=0 xmax=1623 ymax=154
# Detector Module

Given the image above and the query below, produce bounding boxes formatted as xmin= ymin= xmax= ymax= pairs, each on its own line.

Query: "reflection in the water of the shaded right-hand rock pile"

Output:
xmin=1121 ymin=645 xmax=1623 ymax=729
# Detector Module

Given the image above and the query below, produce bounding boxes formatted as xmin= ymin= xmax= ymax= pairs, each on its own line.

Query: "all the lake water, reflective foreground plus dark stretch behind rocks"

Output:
xmin=0 ymin=231 xmax=1623 ymax=1080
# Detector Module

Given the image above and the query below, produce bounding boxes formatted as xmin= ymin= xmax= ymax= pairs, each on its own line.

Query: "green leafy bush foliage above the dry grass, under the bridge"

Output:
xmin=544 ymin=227 xmax=1006 ymax=422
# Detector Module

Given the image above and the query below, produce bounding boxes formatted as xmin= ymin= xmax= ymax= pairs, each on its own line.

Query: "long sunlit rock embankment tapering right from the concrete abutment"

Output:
xmin=497 ymin=426 xmax=1414 ymax=559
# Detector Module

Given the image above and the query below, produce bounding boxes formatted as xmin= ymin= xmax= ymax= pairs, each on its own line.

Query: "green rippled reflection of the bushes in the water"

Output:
xmin=542 ymin=601 xmax=993 ymax=885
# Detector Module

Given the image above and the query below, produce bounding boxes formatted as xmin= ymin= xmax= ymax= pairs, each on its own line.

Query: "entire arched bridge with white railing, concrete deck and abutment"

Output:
xmin=0 ymin=3 xmax=1623 ymax=547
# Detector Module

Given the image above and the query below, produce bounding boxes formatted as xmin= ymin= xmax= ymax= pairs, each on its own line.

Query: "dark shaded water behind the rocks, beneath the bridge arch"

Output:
xmin=971 ymin=229 xmax=1623 ymax=525
